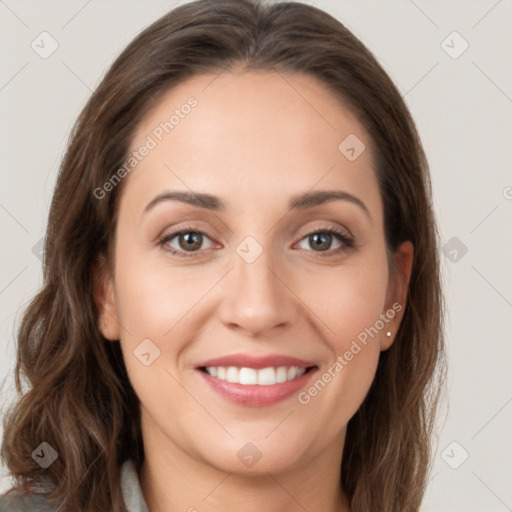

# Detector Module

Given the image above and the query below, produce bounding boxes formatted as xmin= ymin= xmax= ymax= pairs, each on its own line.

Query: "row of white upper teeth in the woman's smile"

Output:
xmin=206 ymin=366 xmax=306 ymax=386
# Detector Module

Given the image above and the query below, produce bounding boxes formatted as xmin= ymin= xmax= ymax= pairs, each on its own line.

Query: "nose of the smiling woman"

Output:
xmin=219 ymin=245 xmax=300 ymax=338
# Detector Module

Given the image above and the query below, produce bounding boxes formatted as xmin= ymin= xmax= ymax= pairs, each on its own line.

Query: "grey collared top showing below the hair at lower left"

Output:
xmin=0 ymin=460 xmax=149 ymax=512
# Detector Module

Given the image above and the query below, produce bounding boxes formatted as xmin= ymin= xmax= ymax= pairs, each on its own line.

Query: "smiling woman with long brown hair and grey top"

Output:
xmin=0 ymin=0 xmax=444 ymax=512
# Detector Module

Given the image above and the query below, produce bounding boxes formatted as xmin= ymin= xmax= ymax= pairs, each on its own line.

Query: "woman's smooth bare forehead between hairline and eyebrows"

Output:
xmin=126 ymin=71 xmax=379 ymax=217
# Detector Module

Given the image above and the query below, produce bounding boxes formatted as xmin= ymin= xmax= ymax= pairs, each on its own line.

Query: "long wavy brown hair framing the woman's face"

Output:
xmin=1 ymin=0 xmax=445 ymax=512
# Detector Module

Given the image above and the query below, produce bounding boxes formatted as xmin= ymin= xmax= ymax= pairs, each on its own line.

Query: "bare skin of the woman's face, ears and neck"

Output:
xmin=95 ymin=71 xmax=413 ymax=512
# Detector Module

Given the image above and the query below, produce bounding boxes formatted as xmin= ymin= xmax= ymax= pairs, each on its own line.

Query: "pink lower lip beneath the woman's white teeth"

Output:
xmin=197 ymin=368 xmax=316 ymax=407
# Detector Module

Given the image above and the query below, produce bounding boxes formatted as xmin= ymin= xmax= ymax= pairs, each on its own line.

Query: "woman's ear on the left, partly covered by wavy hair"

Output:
xmin=91 ymin=254 xmax=119 ymax=341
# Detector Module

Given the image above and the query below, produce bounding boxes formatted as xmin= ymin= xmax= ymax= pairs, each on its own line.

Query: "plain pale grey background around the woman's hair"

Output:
xmin=0 ymin=0 xmax=512 ymax=512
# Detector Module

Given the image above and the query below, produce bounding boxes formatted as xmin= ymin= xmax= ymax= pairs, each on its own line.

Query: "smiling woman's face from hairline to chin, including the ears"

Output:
xmin=99 ymin=72 xmax=412 ymax=473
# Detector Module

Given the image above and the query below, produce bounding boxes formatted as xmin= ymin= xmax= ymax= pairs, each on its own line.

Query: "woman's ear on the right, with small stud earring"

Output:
xmin=380 ymin=240 xmax=414 ymax=350
